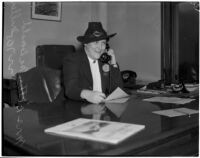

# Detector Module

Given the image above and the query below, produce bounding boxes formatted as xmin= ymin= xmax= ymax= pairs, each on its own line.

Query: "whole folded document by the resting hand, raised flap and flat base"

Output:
xmin=105 ymin=87 xmax=129 ymax=103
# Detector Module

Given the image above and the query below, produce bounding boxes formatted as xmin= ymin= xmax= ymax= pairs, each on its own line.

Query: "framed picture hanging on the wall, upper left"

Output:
xmin=31 ymin=2 xmax=62 ymax=21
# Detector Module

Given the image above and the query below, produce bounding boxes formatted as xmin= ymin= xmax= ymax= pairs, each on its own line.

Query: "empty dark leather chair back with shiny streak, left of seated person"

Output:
xmin=16 ymin=67 xmax=61 ymax=103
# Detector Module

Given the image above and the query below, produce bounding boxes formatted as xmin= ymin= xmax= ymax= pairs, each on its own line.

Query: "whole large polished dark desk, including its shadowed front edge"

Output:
xmin=3 ymin=94 xmax=199 ymax=156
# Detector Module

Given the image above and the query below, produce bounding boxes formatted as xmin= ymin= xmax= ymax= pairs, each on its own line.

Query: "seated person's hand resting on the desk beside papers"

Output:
xmin=81 ymin=90 xmax=106 ymax=104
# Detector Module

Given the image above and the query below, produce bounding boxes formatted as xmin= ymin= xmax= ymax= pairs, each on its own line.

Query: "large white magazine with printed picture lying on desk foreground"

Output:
xmin=45 ymin=118 xmax=145 ymax=144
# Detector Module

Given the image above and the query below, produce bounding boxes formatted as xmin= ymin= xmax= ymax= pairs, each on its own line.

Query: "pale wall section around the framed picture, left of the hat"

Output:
xmin=3 ymin=2 xmax=92 ymax=78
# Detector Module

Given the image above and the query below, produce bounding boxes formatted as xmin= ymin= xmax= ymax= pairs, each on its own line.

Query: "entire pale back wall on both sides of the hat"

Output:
xmin=3 ymin=2 xmax=161 ymax=80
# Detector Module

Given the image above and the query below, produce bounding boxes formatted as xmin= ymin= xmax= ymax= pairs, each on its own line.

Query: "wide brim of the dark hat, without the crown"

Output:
xmin=77 ymin=33 xmax=117 ymax=43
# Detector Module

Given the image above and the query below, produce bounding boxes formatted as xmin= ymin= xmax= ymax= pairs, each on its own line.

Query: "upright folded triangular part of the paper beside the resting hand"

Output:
xmin=105 ymin=87 xmax=129 ymax=101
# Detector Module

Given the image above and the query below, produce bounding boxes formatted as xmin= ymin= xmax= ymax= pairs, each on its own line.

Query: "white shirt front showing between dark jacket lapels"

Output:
xmin=88 ymin=57 xmax=102 ymax=92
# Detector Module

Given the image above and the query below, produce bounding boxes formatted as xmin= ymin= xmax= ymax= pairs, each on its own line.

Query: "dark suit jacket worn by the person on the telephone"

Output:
xmin=63 ymin=48 xmax=123 ymax=100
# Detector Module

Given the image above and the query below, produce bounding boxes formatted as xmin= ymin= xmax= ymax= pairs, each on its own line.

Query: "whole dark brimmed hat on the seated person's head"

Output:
xmin=77 ymin=22 xmax=117 ymax=43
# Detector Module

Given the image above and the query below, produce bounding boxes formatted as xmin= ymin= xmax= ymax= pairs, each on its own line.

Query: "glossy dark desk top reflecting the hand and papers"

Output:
xmin=3 ymin=94 xmax=199 ymax=155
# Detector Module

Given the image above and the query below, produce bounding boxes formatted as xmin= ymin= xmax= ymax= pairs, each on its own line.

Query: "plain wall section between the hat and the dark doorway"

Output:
xmin=108 ymin=2 xmax=161 ymax=81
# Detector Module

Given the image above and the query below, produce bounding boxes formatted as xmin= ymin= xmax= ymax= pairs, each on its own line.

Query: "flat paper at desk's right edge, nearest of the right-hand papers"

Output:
xmin=152 ymin=108 xmax=199 ymax=117
